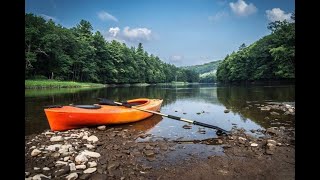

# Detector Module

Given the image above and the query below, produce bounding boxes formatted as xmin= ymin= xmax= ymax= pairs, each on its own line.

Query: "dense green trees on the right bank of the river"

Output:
xmin=217 ymin=13 xmax=295 ymax=82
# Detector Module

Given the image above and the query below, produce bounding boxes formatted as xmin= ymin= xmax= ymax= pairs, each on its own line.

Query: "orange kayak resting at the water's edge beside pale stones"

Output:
xmin=44 ymin=98 xmax=163 ymax=131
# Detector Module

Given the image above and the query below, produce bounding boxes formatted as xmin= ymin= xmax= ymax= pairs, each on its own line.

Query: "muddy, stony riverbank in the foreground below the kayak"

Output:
xmin=25 ymin=122 xmax=295 ymax=180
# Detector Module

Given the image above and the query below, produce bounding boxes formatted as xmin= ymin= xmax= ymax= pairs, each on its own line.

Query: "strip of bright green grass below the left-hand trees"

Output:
xmin=24 ymin=80 xmax=105 ymax=89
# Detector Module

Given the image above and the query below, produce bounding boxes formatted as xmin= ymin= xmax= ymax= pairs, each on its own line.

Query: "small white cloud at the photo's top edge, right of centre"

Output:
xmin=229 ymin=0 xmax=257 ymax=16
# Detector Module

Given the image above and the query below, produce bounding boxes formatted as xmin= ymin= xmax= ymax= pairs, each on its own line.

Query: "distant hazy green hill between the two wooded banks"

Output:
xmin=182 ymin=60 xmax=222 ymax=83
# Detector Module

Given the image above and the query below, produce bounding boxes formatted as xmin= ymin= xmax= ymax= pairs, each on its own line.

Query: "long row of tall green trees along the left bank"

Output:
xmin=25 ymin=13 xmax=199 ymax=84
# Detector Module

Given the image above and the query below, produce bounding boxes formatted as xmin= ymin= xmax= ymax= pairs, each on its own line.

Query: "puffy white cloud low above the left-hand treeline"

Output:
xmin=105 ymin=26 xmax=153 ymax=43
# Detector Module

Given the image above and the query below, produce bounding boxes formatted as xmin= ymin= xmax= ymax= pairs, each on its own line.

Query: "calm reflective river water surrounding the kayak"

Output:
xmin=25 ymin=84 xmax=295 ymax=140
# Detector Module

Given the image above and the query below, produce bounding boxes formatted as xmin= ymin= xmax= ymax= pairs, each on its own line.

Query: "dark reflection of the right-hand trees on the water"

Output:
xmin=217 ymin=85 xmax=295 ymax=128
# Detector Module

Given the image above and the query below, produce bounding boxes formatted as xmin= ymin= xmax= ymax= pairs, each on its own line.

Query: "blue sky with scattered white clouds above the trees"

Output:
xmin=25 ymin=0 xmax=295 ymax=66
